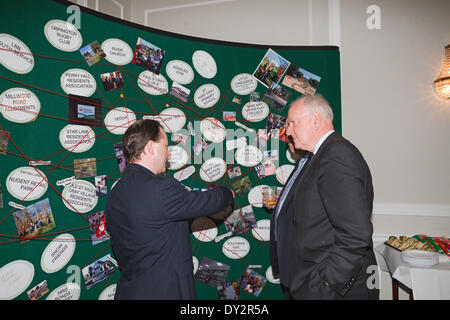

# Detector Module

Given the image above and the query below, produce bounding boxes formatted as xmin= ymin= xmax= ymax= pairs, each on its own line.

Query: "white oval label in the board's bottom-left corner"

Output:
xmin=0 ymin=260 xmax=34 ymax=300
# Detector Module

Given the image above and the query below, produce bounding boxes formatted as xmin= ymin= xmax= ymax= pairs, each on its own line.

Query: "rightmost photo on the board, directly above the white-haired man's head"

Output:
xmin=281 ymin=64 xmax=321 ymax=96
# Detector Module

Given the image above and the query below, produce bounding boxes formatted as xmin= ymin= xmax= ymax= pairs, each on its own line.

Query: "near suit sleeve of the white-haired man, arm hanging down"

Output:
xmin=318 ymin=142 xmax=373 ymax=296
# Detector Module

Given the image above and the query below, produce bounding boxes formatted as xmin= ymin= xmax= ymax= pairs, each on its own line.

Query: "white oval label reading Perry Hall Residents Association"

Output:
xmin=60 ymin=69 xmax=97 ymax=97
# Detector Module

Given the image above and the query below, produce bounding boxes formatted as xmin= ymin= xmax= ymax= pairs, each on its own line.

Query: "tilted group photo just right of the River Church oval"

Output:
xmin=132 ymin=38 xmax=166 ymax=74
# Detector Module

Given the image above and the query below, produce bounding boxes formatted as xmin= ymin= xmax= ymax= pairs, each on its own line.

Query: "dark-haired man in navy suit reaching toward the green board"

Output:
xmin=106 ymin=120 xmax=233 ymax=300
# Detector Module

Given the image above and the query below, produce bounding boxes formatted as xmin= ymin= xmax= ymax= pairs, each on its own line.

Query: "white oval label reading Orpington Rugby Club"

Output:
xmin=44 ymin=19 xmax=83 ymax=52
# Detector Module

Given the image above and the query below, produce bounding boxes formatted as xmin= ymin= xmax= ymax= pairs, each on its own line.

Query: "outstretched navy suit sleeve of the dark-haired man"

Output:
xmin=160 ymin=177 xmax=233 ymax=221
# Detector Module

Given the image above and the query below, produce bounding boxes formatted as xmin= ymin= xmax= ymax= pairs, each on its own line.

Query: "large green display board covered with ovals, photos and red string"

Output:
xmin=0 ymin=0 xmax=341 ymax=300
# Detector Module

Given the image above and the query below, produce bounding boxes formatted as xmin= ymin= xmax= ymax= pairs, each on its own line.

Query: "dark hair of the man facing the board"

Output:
xmin=123 ymin=119 xmax=162 ymax=163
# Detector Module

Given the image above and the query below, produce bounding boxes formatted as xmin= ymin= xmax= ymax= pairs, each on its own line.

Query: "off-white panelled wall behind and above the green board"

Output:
xmin=73 ymin=0 xmax=450 ymax=299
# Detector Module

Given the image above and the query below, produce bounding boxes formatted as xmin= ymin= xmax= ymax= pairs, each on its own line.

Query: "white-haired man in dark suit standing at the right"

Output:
xmin=287 ymin=95 xmax=379 ymax=299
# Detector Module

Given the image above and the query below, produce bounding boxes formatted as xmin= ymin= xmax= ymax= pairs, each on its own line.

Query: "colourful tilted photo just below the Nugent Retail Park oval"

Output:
xmin=13 ymin=198 xmax=56 ymax=244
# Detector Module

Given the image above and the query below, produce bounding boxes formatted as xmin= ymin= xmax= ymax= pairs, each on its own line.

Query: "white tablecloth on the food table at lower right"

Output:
xmin=375 ymin=244 xmax=450 ymax=300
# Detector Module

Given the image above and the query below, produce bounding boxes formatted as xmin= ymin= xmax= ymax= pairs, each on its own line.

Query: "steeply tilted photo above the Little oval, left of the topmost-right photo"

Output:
xmin=253 ymin=49 xmax=290 ymax=87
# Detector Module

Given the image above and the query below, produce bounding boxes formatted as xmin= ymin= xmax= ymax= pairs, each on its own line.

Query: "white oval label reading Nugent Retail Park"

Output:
xmin=6 ymin=167 xmax=48 ymax=201
